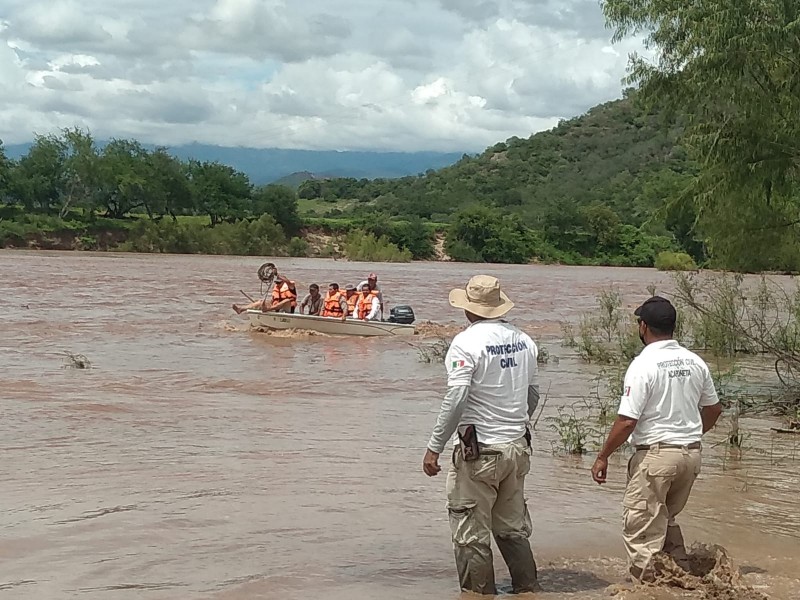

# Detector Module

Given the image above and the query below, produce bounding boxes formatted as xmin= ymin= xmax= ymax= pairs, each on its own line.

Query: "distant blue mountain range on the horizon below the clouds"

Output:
xmin=5 ymin=142 xmax=462 ymax=186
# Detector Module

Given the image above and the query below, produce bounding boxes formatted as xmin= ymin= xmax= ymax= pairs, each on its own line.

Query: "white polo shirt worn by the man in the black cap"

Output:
xmin=619 ymin=340 xmax=719 ymax=445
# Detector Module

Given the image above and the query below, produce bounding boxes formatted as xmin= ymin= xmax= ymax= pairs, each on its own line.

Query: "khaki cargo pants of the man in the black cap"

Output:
xmin=622 ymin=444 xmax=701 ymax=579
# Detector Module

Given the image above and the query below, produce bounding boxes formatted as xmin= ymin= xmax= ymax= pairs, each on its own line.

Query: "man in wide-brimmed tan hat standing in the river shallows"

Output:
xmin=422 ymin=275 xmax=539 ymax=594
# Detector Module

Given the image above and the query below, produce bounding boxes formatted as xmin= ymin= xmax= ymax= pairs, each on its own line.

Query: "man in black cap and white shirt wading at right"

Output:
xmin=592 ymin=296 xmax=722 ymax=580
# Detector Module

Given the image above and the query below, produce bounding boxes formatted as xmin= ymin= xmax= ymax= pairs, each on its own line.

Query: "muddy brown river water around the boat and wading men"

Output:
xmin=0 ymin=251 xmax=800 ymax=600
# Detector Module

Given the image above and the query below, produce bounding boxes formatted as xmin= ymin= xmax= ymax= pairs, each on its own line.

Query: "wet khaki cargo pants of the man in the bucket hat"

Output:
xmin=447 ymin=438 xmax=538 ymax=594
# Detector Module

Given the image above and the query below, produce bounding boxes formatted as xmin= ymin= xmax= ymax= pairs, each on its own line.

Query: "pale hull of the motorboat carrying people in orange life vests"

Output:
xmin=247 ymin=310 xmax=415 ymax=337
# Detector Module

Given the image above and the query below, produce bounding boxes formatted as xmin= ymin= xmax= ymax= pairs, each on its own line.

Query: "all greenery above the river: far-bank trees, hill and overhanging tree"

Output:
xmin=0 ymin=0 xmax=800 ymax=272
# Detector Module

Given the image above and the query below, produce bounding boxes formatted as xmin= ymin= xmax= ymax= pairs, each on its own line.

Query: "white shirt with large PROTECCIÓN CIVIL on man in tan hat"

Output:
xmin=445 ymin=319 xmax=538 ymax=444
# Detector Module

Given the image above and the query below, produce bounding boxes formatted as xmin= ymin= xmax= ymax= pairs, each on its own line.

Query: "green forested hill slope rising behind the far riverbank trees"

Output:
xmin=300 ymin=92 xmax=690 ymax=224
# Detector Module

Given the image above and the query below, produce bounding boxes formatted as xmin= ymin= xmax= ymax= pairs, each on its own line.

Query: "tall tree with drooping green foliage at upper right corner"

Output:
xmin=603 ymin=0 xmax=800 ymax=243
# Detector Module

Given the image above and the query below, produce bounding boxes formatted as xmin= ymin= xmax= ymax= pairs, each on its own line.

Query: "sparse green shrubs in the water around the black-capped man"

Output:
xmin=546 ymin=273 xmax=800 ymax=454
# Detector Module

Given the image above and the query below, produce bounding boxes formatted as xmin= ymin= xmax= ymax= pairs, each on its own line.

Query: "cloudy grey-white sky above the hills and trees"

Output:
xmin=0 ymin=0 xmax=638 ymax=152
